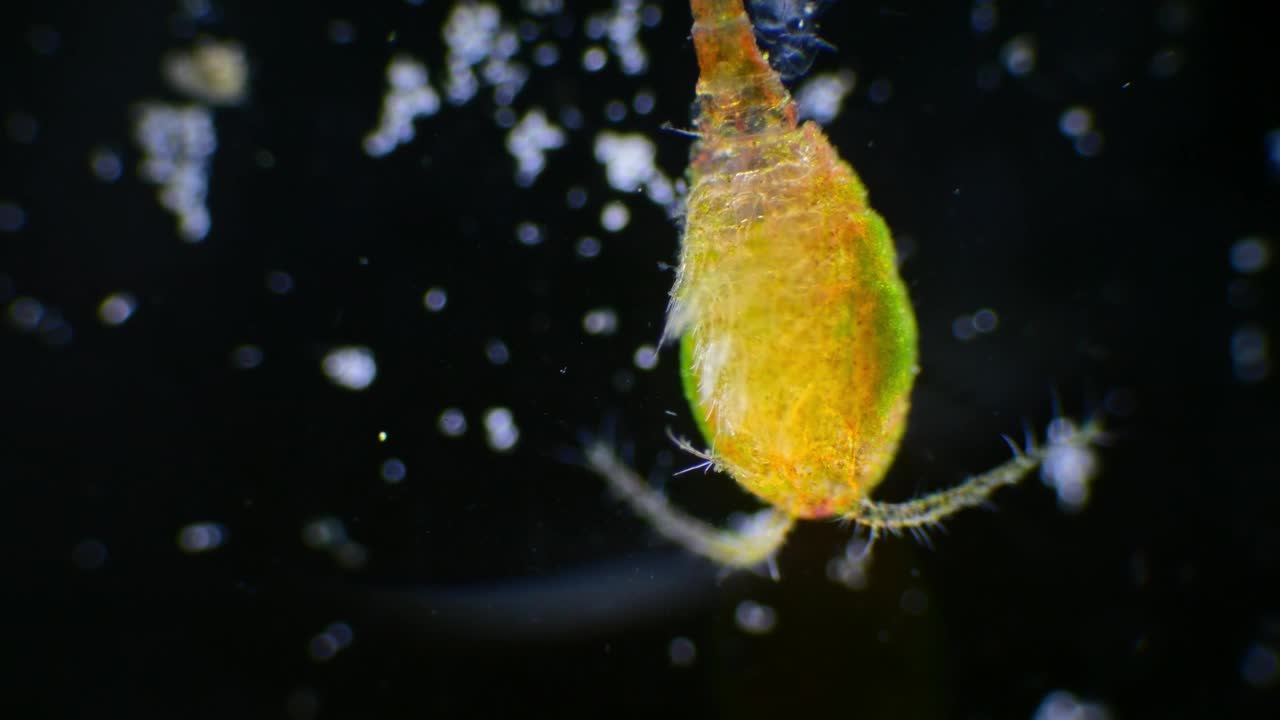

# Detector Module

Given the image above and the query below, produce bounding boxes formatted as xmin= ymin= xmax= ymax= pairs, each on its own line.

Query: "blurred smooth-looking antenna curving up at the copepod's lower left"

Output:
xmin=586 ymin=442 xmax=795 ymax=569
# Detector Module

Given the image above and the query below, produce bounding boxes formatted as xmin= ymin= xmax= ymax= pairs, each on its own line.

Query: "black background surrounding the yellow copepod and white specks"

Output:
xmin=0 ymin=0 xmax=1280 ymax=719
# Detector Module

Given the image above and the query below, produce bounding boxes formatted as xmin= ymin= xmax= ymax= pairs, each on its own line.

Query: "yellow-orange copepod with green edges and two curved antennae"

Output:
xmin=586 ymin=0 xmax=1101 ymax=568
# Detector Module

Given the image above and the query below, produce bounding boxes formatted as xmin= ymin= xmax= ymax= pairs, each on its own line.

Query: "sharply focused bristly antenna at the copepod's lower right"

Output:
xmin=845 ymin=419 xmax=1102 ymax=537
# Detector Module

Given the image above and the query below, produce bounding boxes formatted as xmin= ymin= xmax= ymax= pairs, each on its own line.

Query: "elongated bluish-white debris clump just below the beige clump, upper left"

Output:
xmin=133 ymin=102 xmax=218 ymax=242
